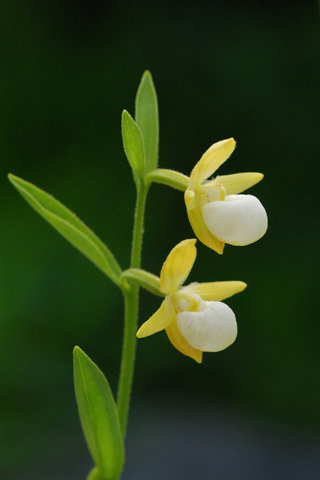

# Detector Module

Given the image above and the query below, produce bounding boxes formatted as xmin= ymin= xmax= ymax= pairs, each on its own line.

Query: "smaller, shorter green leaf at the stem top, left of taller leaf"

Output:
xmin=121 ymin=110 xmax=145 ymax=178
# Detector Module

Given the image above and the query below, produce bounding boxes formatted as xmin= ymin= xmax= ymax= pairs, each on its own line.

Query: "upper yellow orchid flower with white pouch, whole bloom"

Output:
xmin=184 ymin=138 xmax=268 ymax=254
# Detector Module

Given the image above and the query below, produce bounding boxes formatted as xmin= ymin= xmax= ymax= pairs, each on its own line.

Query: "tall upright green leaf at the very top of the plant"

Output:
xmin=135 ymin=71 xmax=159 ymax=173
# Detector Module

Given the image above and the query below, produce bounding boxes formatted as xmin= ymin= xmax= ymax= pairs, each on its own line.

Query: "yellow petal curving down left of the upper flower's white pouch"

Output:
xmin=184 ymin=190 xmax=224 ymax=254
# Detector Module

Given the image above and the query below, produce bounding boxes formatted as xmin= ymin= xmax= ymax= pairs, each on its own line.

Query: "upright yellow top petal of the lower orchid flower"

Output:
xmin=160 ymin=238 xmax=197 ymax=294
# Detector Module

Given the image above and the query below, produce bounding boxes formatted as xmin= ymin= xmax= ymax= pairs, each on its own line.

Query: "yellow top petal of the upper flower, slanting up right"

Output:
xmin=190 ymin=138 xmax=236 ymax=186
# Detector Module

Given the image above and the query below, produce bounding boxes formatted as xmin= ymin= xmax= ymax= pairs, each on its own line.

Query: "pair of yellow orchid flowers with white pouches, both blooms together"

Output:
xmin=137 ymin=138 xmax=268 ymax=363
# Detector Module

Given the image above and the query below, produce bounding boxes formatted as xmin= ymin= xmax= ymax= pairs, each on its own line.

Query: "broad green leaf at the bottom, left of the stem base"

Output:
xmin=73 ymin=347 xmax=124 ymax=480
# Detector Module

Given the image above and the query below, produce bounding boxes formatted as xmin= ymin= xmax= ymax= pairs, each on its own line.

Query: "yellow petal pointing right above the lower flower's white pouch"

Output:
xmin=180 ymin=281 xmax=247 ymax=302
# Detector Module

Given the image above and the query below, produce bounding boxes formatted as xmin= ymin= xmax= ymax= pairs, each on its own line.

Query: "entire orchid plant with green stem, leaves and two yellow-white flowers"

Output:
xmin=9 ymin=71 xmax=267 ymax=480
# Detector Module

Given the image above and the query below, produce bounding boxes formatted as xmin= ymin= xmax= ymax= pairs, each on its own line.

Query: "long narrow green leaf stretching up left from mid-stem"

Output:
xmin=8 ymin=174 xmax=121 ymax=288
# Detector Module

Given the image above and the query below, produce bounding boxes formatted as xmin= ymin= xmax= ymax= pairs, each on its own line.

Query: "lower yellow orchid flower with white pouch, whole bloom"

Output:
xmin=137 ymin=239 xmax=246 ymax=363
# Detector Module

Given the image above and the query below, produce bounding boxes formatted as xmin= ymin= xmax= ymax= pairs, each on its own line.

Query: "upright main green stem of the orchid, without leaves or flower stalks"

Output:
xmin=117 ymin=184 xmax=148 ymax=437
